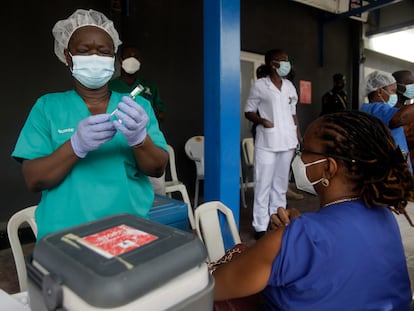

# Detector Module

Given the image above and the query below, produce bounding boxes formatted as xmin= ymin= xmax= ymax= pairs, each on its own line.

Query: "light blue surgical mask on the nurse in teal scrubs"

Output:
xmin=71 ymin=54 xmax=115 ymax=89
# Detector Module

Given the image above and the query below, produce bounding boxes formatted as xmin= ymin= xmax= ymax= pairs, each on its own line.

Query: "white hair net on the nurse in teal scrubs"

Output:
xmin=52 ymin=9 xmax=122 ymax=63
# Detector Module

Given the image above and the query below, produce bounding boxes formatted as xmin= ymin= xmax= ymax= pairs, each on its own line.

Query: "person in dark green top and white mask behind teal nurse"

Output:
xmin=109 ymin=45 xmax=165 ymax=195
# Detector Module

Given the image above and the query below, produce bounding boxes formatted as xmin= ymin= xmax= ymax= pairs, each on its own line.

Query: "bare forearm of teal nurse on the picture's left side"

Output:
xmin=22 ymin=141 xmax=79 ymax=192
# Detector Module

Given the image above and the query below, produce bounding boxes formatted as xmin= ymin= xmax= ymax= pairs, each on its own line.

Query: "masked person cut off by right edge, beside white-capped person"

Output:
xmin=392 ymin=70 xmax=414 ymax=163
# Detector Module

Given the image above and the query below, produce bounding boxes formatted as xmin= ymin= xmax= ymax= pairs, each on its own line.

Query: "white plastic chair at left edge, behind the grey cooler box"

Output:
xmin=7 ymin=205 xmax=37 ymax=292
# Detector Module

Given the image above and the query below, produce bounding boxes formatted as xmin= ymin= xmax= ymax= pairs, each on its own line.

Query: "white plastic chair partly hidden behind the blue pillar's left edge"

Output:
xmin=184 ymin=136 xmax=204 ymax=209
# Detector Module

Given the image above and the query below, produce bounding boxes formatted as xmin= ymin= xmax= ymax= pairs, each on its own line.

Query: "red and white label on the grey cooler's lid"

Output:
xmin=78 ymin=225 xmax=158 ymax=258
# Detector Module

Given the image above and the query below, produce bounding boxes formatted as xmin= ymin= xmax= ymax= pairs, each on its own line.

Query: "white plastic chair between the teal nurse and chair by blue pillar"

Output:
xmin=165 ymin=145 xmax=195 ymax=230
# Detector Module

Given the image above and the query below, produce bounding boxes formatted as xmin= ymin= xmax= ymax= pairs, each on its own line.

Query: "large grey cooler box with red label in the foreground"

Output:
xmin=27 ymin=214 xmax=214 ymax=311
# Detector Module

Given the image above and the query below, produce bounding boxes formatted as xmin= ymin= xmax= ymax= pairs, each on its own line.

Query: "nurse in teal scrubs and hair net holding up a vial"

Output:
xmin=12 ymin=10 xmax=168 ymax=239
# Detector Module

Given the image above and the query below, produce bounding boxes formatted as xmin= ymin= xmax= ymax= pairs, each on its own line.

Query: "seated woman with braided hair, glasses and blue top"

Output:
xmin=214 ymin=111 xmax=414 ymax=311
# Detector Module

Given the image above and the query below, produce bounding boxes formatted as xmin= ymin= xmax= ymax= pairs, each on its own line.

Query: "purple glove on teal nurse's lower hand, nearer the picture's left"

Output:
xmin=70 ymin=114 xmax=116 ymax=158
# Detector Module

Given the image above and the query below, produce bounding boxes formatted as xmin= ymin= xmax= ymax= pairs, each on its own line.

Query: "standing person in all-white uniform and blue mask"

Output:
xmin=245 ymin=49 xmax=301 ymax=239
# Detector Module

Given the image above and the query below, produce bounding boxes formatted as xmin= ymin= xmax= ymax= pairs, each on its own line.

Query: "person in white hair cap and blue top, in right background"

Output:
xmin=360 ymin=70 xmax=412 ymax=172
